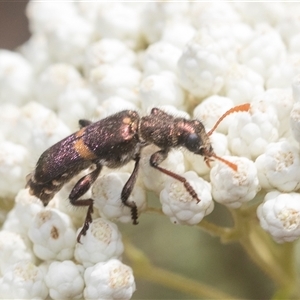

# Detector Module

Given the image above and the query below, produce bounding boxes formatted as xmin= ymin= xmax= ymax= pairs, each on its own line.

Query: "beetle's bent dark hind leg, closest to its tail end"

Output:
xmin=69 ymin=164 xmax=102 ymax=243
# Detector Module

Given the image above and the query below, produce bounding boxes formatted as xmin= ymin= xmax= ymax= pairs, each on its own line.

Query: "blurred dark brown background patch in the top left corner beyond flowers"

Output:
xmin=0 ymin=0 xmax=29 ymax=50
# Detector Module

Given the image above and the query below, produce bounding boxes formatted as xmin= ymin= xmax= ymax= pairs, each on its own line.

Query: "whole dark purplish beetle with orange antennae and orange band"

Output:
xmin=26 ymin=103 xmax=250 ymax=242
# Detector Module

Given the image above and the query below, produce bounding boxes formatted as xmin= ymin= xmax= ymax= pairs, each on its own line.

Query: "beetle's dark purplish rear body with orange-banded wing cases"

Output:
xmin=27 ymin=111 xmax=139 ymax=206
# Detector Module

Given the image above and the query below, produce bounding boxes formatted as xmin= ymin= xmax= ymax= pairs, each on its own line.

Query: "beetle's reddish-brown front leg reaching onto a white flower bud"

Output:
xmin=150 ymin=149 xmax=200 ymax=203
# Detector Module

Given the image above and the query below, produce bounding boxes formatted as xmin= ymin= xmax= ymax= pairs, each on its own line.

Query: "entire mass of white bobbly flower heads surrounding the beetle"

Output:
xmin=0 ymin=1 xmax=300 ymax=299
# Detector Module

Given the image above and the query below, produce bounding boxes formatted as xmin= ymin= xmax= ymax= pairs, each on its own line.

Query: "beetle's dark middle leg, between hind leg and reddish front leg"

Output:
xmin=121 ymin=156 xmax=140 ymax=225
